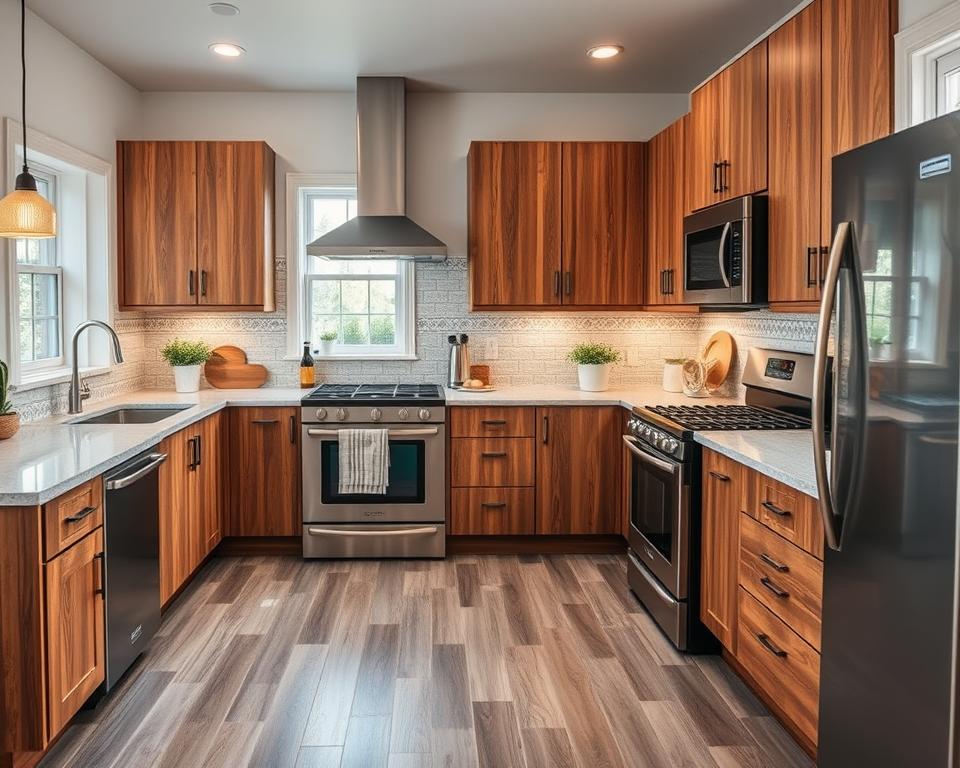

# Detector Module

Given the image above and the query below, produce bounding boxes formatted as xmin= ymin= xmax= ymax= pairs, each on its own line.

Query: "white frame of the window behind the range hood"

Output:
xmin=286 ymin=173 xmax=417 ymax=361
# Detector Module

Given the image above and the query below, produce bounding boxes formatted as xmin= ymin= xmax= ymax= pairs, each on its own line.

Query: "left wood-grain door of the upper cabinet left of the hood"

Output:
xmin=117 ymin=141 xmax=197 ymax=309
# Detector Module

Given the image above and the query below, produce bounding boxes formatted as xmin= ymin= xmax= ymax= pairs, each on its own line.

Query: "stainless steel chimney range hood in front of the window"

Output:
xmin=307 ymin=77 xmax=447 ymax=262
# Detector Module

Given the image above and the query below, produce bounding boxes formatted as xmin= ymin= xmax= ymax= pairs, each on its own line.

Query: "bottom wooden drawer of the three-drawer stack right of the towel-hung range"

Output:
xmin=450 ymin=488 xmax=536 ymax=536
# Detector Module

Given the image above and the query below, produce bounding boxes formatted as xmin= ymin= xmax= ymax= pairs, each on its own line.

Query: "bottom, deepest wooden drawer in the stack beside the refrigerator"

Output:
xmin=737 ymin=588 xmax=820 ymax=743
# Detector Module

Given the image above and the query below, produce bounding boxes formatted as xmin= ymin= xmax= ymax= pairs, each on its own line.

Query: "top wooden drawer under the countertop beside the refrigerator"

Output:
xmin=744 ymin=472 xmax=823 ymax=560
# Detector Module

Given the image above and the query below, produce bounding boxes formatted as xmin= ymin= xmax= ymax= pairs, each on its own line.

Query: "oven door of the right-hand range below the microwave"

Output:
xmin=623 ymin=435 xmax=690 ymax=600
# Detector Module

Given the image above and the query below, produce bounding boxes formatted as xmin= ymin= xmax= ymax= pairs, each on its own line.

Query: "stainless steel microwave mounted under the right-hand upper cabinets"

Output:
xmin=683 ymin=195 xmax=767 ymax=309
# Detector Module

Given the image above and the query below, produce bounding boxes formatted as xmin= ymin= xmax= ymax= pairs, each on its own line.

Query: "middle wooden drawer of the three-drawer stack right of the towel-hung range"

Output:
xmin=450 ymin=437 xmax=534 ymax=488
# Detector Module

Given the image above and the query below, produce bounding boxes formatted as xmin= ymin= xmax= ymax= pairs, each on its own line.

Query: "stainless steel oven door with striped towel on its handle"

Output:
xmin=302 ymin=424 xmax=446 ymax=523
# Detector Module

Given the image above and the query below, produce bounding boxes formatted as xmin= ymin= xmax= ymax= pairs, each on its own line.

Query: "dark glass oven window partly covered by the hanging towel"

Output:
xmin=320 ymin=440 xmax=426 ymax=504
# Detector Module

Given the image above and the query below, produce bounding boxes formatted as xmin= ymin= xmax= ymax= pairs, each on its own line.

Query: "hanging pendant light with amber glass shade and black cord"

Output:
xmin=0 ymin=0 xmax=57 ymax=240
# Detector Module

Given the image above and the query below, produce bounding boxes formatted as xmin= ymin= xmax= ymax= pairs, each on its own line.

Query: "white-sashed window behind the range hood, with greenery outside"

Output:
xmin=288 ymin=183 xmax=414 ymax=359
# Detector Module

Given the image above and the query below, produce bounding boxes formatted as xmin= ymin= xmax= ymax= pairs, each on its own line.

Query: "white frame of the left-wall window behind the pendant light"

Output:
xmin=0 ymin=118 xmax=116 ymax=391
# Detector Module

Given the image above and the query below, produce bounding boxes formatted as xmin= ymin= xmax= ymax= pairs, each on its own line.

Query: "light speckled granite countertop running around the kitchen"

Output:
xmin=0 ymin=384 xmax=817 ymax=505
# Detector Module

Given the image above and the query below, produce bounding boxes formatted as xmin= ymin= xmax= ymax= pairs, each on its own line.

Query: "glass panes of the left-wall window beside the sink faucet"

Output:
xmin=14 ymin=165 xmax=63 ymax=371
